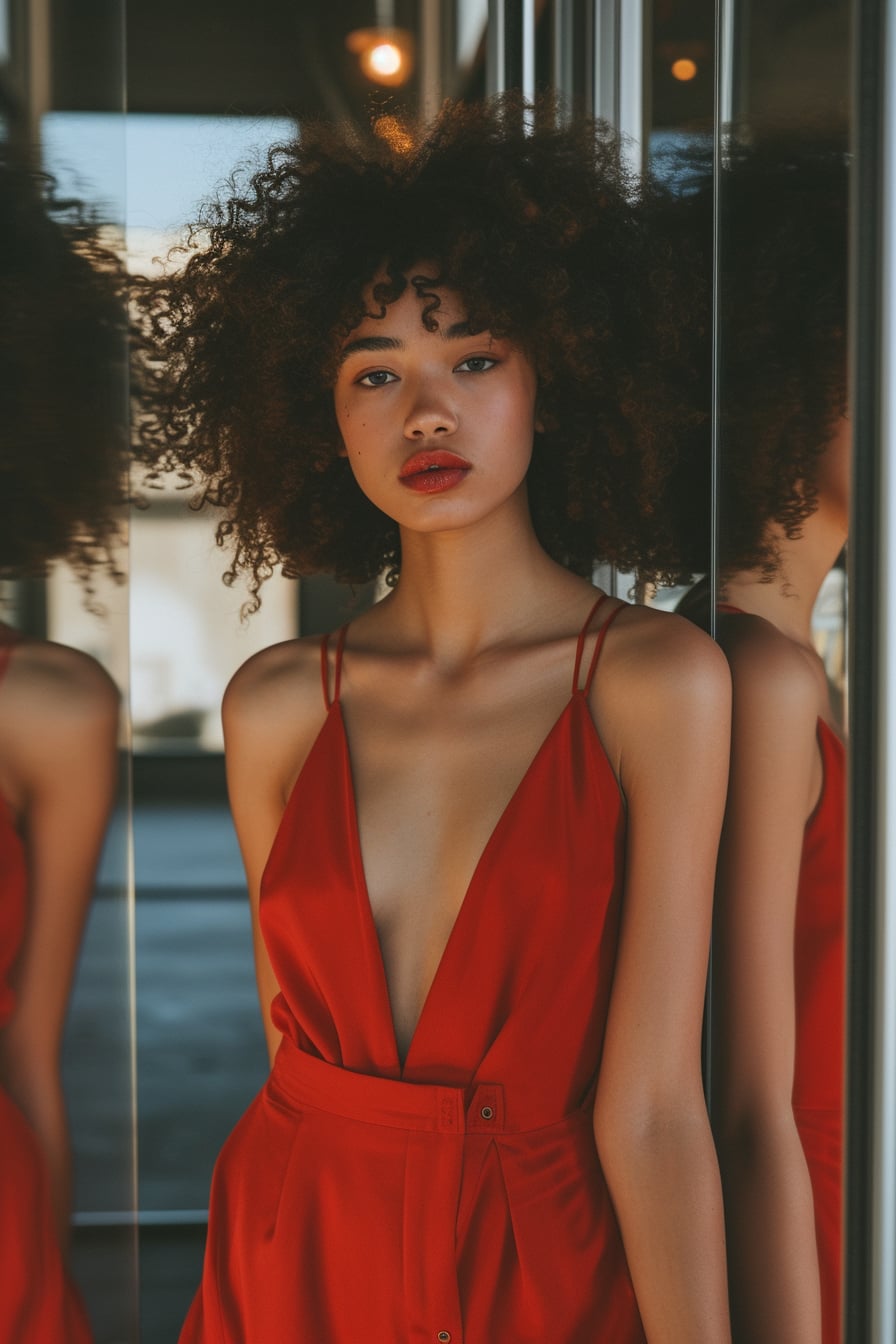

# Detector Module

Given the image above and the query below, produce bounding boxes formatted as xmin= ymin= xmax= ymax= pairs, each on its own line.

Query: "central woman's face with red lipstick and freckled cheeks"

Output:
xmin=334 ymin=271 xmax=536 ymax=532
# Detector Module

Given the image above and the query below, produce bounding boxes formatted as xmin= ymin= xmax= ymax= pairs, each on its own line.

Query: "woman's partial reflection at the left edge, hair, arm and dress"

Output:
xmin=0 ymin=159 xmax=122 ymax=1344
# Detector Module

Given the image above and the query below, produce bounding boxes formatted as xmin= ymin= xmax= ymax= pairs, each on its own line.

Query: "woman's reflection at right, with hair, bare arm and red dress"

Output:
xmin=685 ymin=132 xmax=850 ymax=1344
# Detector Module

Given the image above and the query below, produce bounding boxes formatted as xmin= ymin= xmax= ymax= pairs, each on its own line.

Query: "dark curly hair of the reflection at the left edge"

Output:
xmin=0 ymin=152 xmax=128 ymax=593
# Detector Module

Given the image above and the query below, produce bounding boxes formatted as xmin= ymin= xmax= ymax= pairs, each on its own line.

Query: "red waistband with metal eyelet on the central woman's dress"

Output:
xmin=267 ymin=1036 xmax=584 ymax=1134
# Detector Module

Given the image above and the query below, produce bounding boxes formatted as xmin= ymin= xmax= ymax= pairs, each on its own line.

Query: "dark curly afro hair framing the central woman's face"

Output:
xmin=138 ymin=95 xmax=693 ymax=610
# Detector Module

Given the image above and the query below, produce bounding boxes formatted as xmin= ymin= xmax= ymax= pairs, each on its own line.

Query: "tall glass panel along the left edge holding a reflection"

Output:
xmin=0 ymin=0 xmax=137 ymax=1344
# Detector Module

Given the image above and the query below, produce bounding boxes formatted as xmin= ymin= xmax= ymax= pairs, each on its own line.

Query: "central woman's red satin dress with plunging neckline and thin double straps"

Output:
xmin=181 ymin=596 xmax=643 ymax=1344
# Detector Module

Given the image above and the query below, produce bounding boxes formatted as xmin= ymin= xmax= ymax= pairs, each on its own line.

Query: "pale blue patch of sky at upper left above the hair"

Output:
xmin=41 ymin=115 xmax=296 ymax=234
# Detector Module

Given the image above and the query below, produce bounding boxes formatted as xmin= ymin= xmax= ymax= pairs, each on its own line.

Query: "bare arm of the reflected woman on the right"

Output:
xmin=713 ymin=618 xmax=821 ymax=1344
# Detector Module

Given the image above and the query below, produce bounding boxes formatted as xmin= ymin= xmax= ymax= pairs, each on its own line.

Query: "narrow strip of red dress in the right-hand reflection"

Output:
xmin=794 ymin=719 xmax=846 ymax=1344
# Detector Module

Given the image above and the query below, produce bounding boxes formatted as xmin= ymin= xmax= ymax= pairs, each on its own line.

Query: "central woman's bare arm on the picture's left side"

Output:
xmin=222 ymin=641 xmax=324 ymax=1063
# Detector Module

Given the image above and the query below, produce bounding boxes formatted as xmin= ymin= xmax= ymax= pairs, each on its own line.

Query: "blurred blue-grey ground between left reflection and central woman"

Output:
xmin=64 ymin=806 xmax=267 ymax=1344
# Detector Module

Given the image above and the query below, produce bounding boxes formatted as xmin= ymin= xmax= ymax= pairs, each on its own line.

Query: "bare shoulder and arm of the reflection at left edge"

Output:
xmin=0 ymin=641 xmax=118 ymax=1246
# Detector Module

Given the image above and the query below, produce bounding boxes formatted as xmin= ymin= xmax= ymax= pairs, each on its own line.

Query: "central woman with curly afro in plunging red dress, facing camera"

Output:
xmin=145 ymin=99 xmax=729 ymax=1344
